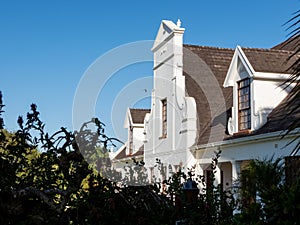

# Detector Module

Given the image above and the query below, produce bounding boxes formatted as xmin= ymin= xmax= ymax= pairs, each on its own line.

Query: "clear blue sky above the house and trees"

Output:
xmin=0 ymin=0 xmax=300 ymax=150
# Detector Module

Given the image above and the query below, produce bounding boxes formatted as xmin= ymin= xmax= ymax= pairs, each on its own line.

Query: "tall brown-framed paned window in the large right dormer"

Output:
xmin=238 ymin=78 xmax=251 ymax=131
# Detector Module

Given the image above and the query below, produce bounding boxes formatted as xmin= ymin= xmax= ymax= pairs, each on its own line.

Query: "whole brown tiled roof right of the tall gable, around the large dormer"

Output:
xmin=183 ymin=45 xmax=300 ymax=145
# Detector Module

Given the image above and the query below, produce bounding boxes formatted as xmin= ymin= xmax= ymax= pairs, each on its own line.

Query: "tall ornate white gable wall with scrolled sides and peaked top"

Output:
xmin=144 ymin=21 xmax=196 ymax=176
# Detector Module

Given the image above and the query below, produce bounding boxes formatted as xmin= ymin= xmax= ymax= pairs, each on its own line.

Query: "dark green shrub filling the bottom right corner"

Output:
xmin=235 ymin=158 xmax=300 ymax=224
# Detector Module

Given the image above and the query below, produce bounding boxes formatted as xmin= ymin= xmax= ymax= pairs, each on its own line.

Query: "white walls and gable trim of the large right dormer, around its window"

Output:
xmin=224 ymin=49 xmax=289 ymax=134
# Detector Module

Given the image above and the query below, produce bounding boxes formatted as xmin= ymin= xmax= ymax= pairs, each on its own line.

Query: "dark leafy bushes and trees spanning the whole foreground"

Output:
xmin=0 ymin=92 xmax=300 ymax=225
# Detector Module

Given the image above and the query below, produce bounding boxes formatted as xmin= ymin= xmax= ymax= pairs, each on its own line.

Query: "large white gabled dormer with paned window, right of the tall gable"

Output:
xmin=223 ymin=46 xmax=288 ymax=135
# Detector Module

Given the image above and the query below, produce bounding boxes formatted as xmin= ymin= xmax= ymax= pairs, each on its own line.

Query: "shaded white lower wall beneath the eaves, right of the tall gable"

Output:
xmin=194 ymin=131 xmax=299 ymax=189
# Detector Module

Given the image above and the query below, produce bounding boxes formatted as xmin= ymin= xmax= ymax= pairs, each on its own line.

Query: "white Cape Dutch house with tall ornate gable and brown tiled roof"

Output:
xmin=115 ymin=20 xmax=300 ymax=188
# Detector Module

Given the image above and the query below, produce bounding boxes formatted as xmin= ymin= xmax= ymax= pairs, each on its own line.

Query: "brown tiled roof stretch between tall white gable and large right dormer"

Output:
xmin=183 ymin=45 xmax=234 ymax=145
